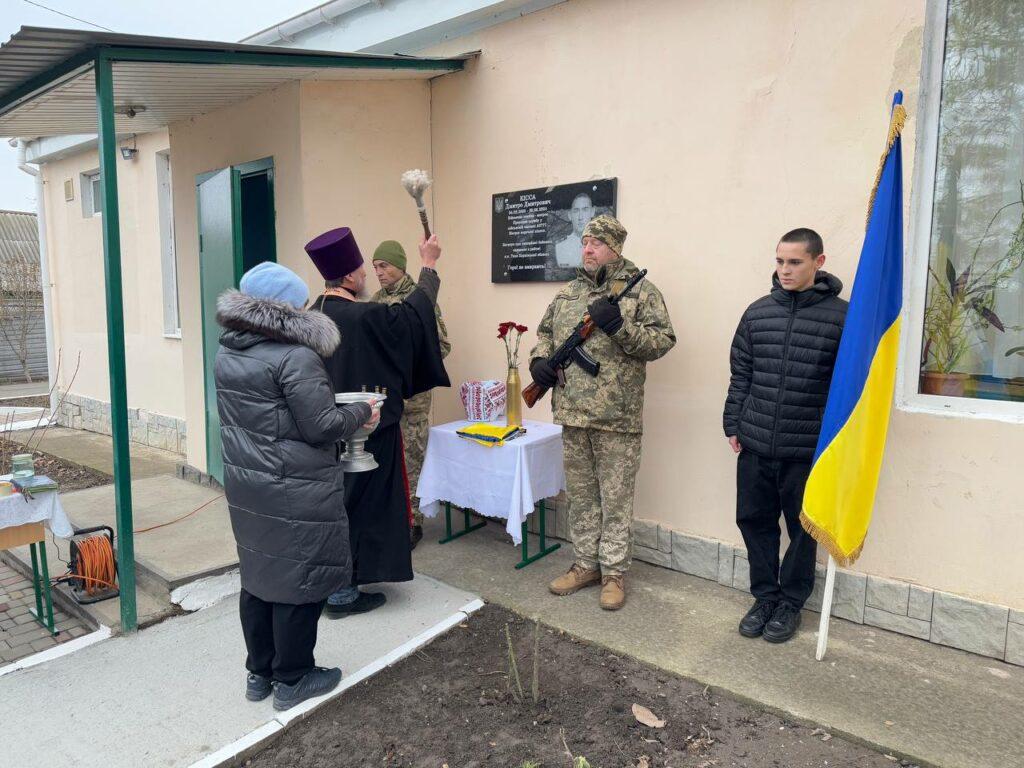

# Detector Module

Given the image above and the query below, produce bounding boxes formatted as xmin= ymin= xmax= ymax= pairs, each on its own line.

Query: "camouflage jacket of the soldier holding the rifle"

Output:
xmin=529 ymin=259 xmax=676 ymax=434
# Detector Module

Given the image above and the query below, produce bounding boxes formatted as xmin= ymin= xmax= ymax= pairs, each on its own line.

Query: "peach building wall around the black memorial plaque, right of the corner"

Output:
xmin=417 ymin=0 xmax=1024 ymax=608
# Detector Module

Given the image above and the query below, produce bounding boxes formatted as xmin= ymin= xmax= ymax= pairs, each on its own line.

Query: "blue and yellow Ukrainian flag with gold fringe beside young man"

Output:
xmin=800 ymin=91 xmax=906 ymax=565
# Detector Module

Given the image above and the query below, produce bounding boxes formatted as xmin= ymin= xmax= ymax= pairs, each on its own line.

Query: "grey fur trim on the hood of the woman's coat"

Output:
xmin=217 ymin=290 xmax=341 ymax=357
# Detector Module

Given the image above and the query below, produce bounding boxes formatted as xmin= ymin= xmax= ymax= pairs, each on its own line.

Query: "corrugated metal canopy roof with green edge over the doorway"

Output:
xmin=0 ymin=27 xmax=469 ymax=137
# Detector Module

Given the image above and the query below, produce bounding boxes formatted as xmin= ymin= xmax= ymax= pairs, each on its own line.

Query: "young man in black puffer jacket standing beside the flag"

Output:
xmin=723 ymin=229 xmax=847 ymax=643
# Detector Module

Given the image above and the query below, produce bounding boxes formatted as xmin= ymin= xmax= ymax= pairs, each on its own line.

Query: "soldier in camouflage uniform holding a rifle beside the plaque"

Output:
xmin=529 ymin=214 xmax=676 ymax=610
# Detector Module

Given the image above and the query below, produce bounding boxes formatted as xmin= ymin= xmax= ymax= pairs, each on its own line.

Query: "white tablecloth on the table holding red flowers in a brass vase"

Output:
xmin=416 ymin=421 xmax=565 ymax=544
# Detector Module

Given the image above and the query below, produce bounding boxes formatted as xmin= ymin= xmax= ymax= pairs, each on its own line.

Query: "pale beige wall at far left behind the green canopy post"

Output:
xmin=43 ymin=131 xmax=185 ymax=418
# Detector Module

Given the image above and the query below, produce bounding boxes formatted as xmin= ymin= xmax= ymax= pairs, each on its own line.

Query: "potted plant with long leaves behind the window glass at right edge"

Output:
xmin=921 ymin=182 xmax=1024 ymax=397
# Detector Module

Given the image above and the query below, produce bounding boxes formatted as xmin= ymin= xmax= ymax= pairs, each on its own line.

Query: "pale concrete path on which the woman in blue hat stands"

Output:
xmin=0 ymin=577 xmax=479 ymax=768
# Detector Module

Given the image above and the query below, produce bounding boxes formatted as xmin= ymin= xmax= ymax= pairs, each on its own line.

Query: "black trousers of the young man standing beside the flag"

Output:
xmin=736 ymin=451 xmax=817 ymax=608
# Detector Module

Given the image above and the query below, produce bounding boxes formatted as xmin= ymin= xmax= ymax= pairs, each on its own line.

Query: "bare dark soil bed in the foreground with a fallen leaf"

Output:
xmin=246 ymin=606 xmax=909 ymax=768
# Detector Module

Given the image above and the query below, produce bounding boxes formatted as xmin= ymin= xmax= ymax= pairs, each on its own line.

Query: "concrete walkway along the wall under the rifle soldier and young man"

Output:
xmin=413 ymin=519 xmax=1024 ymax=768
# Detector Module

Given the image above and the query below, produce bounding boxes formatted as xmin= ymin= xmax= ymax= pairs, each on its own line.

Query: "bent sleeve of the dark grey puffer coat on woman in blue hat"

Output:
xmin=279 ymin=347 xmax=371 ymax=445
